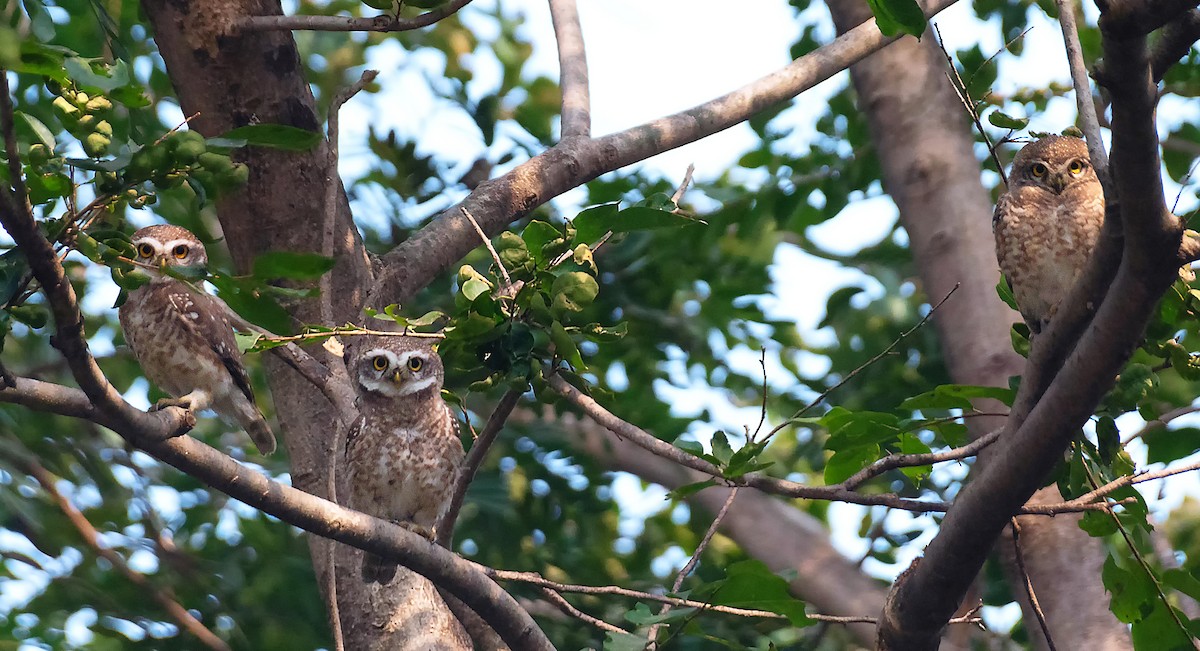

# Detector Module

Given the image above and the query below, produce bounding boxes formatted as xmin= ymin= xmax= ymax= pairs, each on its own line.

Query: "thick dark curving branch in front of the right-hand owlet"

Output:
xmin=880 ymin=0 xmax=1182 ymax=650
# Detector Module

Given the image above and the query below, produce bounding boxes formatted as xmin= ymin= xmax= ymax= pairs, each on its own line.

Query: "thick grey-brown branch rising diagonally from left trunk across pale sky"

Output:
xmin=366 ymin=0 xmax=956 ymax=307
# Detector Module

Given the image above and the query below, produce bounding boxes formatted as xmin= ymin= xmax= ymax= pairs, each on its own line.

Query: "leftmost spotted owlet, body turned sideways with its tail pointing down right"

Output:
xmin=120 ymin=225 xmax=275 ymax=454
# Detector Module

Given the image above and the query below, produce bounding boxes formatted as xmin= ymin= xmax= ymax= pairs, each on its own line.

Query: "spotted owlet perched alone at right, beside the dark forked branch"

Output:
xmin=991 ymin=136 xmax=1104 ymax=333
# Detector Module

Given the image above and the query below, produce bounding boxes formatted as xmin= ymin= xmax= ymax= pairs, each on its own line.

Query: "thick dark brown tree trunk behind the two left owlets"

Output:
xmin=135 ymin=0 xmax=470 ymax=650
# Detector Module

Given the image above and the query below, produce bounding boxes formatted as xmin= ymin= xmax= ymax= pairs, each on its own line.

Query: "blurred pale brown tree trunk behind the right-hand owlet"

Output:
xmin=828 ymin=0 xmax=1132 ymax=650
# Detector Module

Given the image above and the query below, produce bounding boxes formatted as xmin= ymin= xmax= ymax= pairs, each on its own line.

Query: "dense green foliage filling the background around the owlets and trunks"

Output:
xmin=0 ymin=0 xmax=1200 ymax=649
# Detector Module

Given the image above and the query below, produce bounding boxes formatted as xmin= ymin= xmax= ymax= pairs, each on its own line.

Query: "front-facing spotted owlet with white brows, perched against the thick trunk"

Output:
xmin=346 ymin=336 xmax=463 ymax=584
